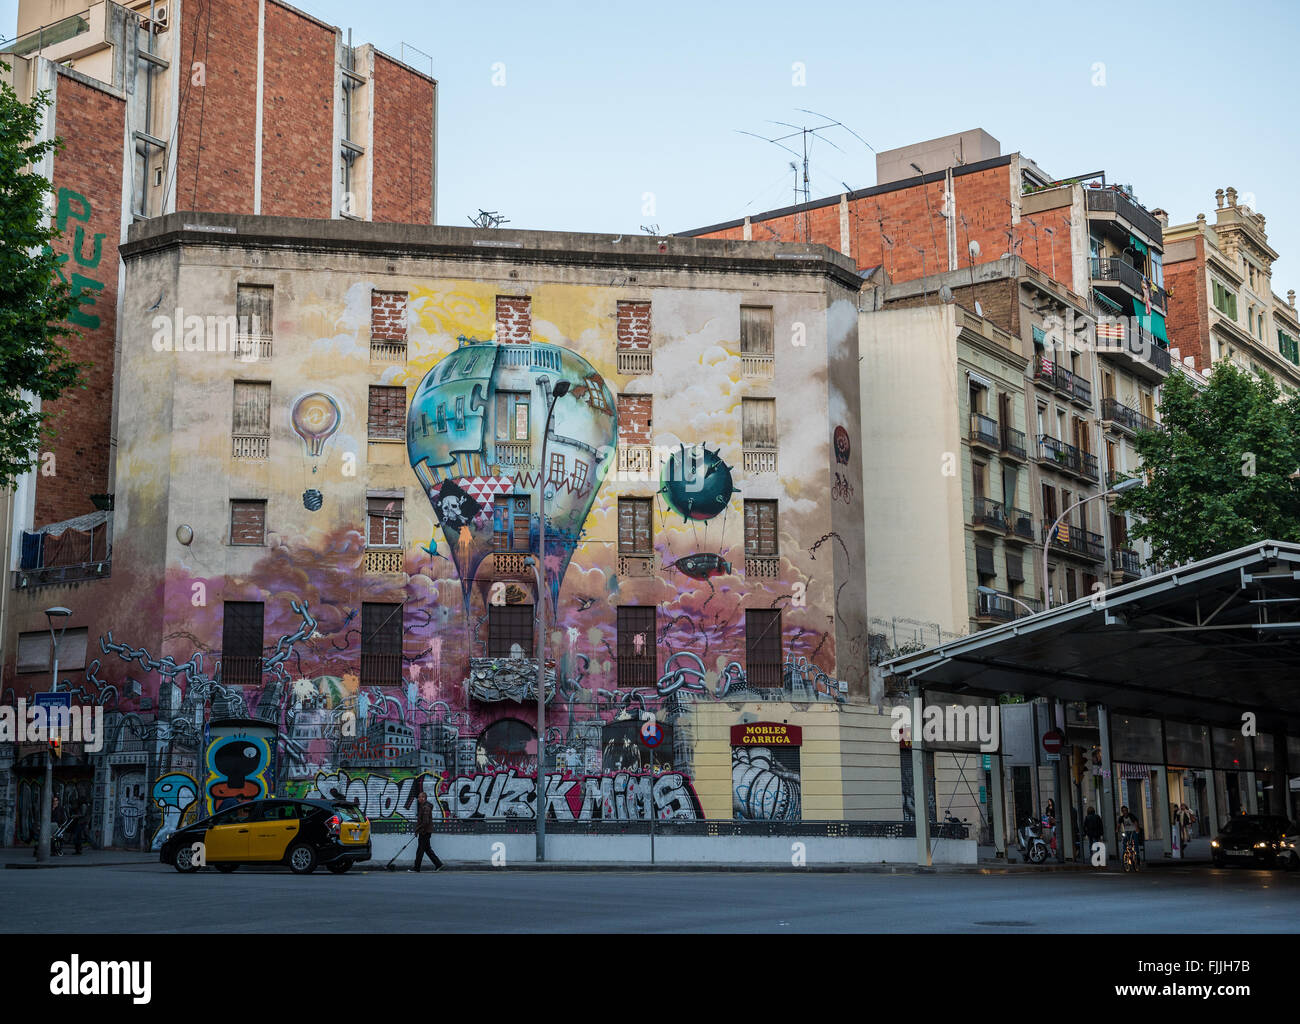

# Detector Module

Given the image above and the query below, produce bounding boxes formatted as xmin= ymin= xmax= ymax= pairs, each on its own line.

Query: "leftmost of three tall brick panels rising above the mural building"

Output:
xmin=176 ymin=0 xmax=260 ymax=213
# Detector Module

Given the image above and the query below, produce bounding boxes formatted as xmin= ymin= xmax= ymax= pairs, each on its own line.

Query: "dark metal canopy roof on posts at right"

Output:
xmin=883 ymin=541 xmax=1300 ymax=736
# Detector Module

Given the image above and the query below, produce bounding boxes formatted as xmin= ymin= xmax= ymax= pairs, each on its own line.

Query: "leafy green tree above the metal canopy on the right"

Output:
xmin=1117 ymin=363 xmax=1300 ymax=564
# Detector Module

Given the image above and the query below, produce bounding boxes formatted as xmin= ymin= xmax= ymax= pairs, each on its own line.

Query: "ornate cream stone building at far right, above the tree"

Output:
xmin=1165 ymin=186 xmax=1300 ymax=389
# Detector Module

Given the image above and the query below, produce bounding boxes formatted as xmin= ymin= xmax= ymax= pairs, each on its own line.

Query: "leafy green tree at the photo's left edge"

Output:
xmin=0 ymin=64 xmax=85 ymax=487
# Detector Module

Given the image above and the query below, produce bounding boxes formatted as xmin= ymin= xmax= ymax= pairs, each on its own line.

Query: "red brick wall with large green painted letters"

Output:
xmin=35 ymin=75 xmax=125 ymax=526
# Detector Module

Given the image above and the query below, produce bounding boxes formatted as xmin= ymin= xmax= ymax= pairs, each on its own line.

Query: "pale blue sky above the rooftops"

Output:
xmin=10 ymin=0 xmax=1300 ymax=288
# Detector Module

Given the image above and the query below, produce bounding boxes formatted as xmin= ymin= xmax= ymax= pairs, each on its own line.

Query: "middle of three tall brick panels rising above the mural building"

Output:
xmin=260 ymin=3 xmax=337 ymax=218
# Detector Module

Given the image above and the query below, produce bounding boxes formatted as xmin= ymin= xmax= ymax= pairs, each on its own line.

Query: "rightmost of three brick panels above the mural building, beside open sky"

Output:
xmin=371 ymin=53 xmax=434 ymax=224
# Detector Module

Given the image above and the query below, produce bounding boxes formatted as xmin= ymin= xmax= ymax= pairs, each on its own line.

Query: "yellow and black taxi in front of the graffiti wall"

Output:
xmin=160 ymin=799 xmax=371 ymax=875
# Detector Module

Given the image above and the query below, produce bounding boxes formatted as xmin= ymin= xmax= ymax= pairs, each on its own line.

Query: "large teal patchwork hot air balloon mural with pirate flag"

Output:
xmin=407 ymin=339 xmax=618 ymax=606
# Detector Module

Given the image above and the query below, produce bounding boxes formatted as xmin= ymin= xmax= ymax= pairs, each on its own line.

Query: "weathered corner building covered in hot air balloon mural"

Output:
xmin=4 ymin=213 xmax=904 ymax=845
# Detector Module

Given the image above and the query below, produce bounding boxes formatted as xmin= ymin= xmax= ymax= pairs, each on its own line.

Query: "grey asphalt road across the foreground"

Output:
xmin=0 ymin=864 xmax=1300 ymax=934
